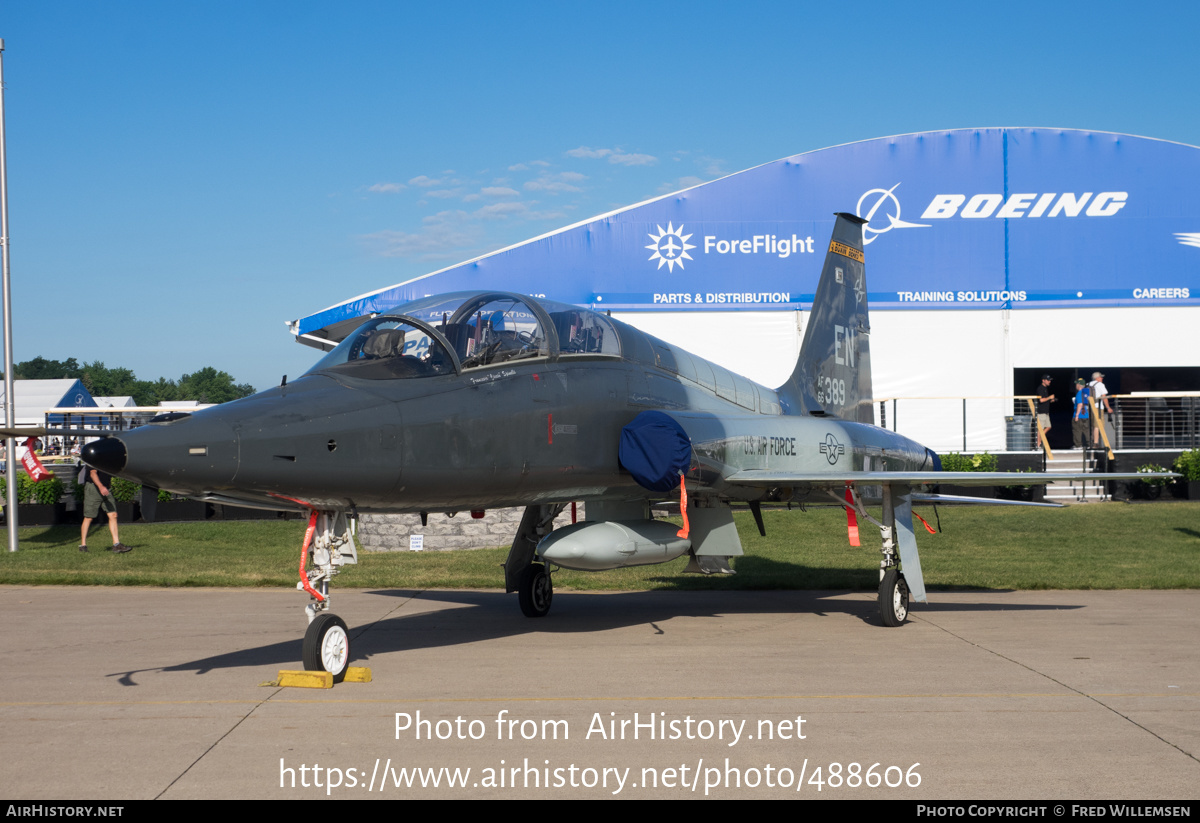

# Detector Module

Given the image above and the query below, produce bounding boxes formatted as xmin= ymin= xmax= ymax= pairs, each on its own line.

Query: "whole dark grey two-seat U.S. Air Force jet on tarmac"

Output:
xmin=28 ymin=214 xmax=1156 ymax=679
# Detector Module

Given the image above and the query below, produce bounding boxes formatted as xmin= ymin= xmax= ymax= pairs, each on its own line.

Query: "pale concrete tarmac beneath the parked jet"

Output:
xmin=0 ymin=587 xmax=1200 ymax=801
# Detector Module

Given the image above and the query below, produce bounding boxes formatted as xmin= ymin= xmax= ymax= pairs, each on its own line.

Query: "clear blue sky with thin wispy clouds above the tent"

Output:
xmin=0 ymin=0 xmax=1200 ymax=389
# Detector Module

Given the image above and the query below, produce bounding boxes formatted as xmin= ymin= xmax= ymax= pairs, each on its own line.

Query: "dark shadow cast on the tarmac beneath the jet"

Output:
xmin=109 ymin=570 xmax=1082 ymax=686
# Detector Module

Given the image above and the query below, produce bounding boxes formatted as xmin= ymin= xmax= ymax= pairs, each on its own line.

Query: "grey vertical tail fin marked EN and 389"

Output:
xmin=776 ymin=212 xmax=875 ymax=423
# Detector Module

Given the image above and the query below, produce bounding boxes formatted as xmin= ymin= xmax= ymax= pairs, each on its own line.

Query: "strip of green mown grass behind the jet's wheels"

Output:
xmin=0 ymin=501 xmax=1200 ymax=590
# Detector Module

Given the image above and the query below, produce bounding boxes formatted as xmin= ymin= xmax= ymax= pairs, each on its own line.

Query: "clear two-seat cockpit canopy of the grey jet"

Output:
xmin=310 ymin=292 xmax=620 ymax=380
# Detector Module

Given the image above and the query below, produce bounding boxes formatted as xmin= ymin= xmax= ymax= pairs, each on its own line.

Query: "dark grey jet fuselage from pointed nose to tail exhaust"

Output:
xmin=87 ymin=299 xmax=929 ymax=512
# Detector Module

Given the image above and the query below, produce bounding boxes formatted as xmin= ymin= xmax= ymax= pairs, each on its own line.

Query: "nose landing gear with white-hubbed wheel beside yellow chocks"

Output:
xmin=296 ymin=510 xmax=359 ymax=683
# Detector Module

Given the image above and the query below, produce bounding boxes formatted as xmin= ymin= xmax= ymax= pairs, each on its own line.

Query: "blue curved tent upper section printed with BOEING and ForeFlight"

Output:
xmin=292 ymin=128 xmax=1200 ymax=348
